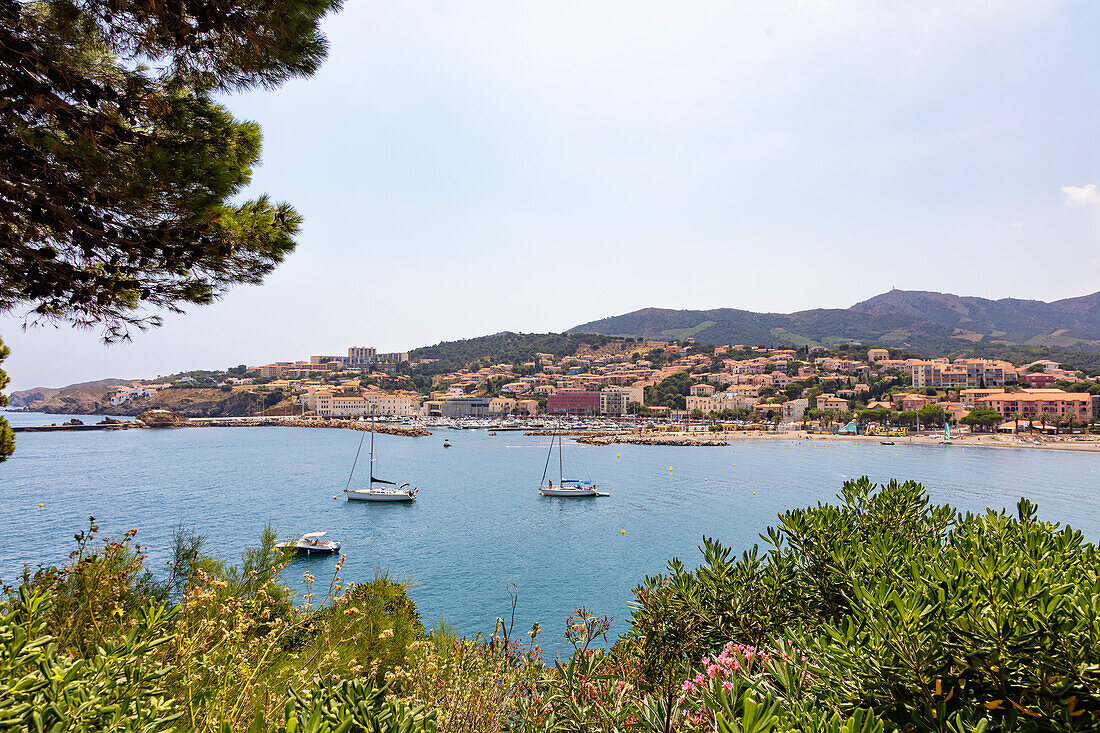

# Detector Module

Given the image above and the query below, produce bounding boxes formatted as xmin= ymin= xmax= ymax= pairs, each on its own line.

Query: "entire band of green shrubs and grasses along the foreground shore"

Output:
xmin=0 ymin=478 xmax=1100 ymax=733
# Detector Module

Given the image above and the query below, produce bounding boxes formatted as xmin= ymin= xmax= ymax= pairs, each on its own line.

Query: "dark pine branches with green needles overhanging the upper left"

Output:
xmin=0 ymin=0 xmax=342 ymax=458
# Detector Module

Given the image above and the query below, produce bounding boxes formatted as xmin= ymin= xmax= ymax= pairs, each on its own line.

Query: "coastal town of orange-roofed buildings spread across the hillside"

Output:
xmin=77 ymin=338 xmax=1100 ymax=435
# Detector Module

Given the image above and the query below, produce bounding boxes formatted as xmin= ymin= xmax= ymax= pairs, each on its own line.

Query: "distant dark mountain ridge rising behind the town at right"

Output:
xmin=567 ymin=289 xmax=1100 ymax=370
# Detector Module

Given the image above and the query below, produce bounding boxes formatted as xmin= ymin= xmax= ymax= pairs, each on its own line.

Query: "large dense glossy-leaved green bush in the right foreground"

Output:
xmin=628 ymin=478 xmax=1100 ymax=732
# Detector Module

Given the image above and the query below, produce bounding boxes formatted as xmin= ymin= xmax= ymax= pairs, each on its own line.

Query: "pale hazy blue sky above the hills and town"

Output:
xmin=0 ymin=0 xmax=1100 ymax=390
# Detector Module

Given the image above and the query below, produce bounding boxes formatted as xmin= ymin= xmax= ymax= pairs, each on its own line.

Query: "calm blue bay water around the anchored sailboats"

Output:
xmin=0 ymin=414 xmax=1100 ymax=643
